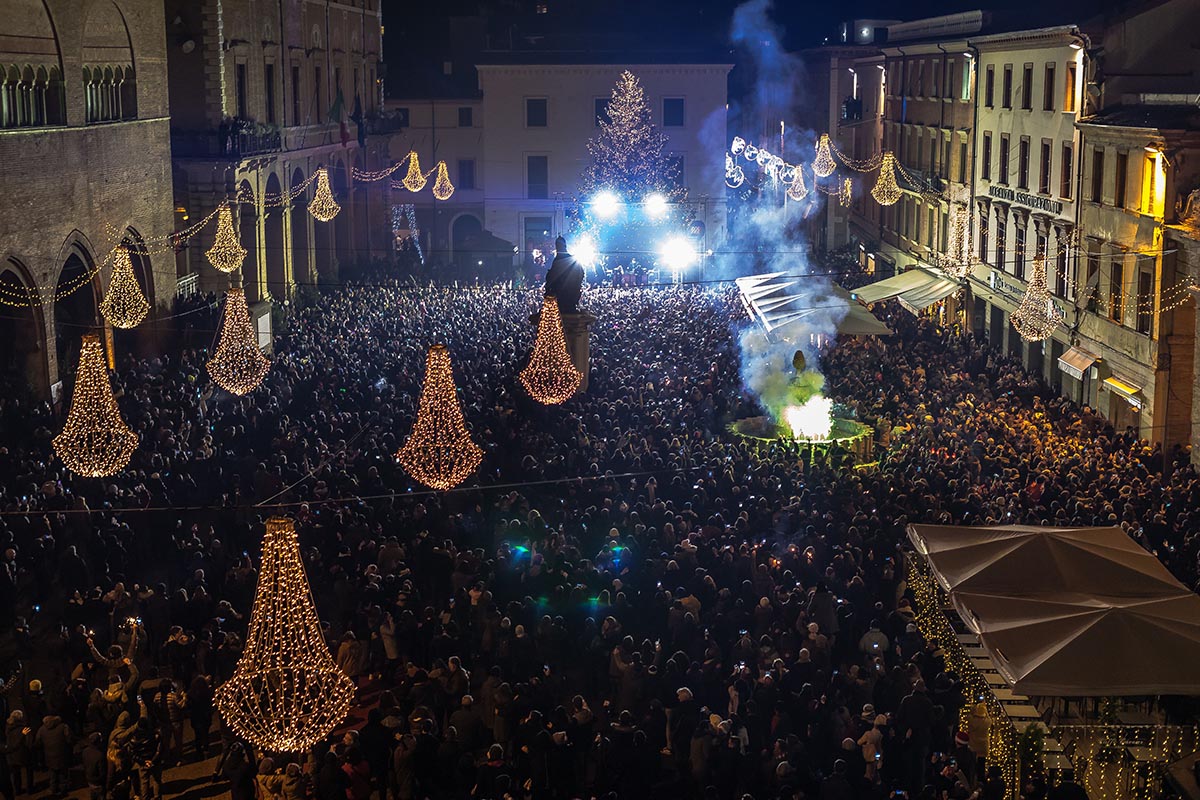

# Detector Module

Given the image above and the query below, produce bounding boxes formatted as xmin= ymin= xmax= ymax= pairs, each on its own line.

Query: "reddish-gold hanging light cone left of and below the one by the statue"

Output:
xmin=396 ymin=344 xmax=484 ymax=489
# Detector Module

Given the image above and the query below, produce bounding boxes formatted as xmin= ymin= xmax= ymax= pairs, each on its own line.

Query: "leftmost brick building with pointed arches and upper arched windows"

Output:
xmin=0 ymin=0 xmax=175 ymax=401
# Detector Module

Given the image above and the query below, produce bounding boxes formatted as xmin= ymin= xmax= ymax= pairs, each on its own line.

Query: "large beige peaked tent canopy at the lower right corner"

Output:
xmin=908 ymin=525 xmax=1200 ymax=697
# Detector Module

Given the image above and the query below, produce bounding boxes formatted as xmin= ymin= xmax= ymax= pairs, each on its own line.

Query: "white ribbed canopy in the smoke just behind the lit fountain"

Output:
xmin=734 ymin=272 xmax=892 ymax=341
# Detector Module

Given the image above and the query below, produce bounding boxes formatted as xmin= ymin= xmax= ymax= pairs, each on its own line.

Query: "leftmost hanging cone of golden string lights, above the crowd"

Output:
xmin=54 ymin=333 xmax=138 ymax=477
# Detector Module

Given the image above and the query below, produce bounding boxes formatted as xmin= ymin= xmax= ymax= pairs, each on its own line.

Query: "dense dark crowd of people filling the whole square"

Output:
xmin=0 ymin=257 xmax=1200 ymax=800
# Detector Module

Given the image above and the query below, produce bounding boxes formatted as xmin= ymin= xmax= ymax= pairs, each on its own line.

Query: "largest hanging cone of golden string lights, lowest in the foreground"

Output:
xmin=215 ymin=517 xmax=354 ymax=753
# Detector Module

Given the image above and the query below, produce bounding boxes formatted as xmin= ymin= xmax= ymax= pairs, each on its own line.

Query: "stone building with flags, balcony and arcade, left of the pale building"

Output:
xmin=166 ymin=0 xmax=390 ymax=345
